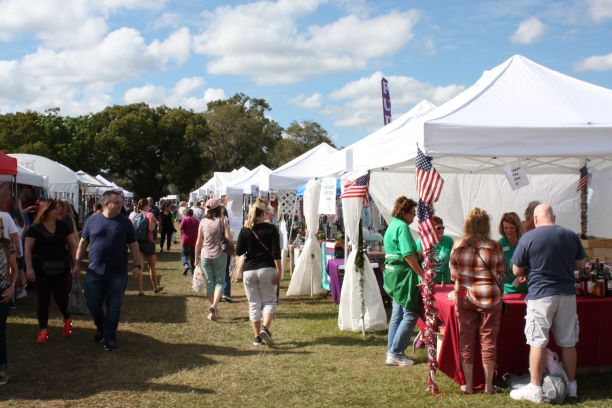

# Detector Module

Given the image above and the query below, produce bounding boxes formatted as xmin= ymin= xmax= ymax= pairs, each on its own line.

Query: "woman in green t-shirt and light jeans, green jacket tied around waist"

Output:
xmin=383 ymin=196 xmax=423 ymax=366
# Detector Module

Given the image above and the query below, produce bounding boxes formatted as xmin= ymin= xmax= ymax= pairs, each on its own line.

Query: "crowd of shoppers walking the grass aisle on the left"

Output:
xmin=0 ymin=190 xmax=281 ymax=385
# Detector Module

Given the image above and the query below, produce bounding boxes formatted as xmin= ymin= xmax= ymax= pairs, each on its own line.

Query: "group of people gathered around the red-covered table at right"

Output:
xmin=383 ymin=197 xmax=586 ymax=402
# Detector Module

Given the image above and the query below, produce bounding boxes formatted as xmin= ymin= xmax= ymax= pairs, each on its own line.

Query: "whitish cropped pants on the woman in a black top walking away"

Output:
xmin=242 ymin=268 xmax=276 ymax=322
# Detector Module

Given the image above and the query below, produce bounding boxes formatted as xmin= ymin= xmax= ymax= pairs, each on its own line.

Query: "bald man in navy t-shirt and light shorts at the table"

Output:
xmin=510 ymin=203 xmax=586 ymax=403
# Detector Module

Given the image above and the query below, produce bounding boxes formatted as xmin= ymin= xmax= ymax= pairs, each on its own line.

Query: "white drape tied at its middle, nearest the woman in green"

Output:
xmin=338 ymin=198 xmax=387 ymax=332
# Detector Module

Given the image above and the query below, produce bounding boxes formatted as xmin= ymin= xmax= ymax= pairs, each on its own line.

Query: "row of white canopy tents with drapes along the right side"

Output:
xmin=194 ymin=55 xmax=612 ymax=330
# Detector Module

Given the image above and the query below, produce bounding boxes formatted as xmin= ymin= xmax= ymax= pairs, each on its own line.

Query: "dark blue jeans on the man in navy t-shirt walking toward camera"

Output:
xmin=85 ymin=272 xmax=128 ymax=342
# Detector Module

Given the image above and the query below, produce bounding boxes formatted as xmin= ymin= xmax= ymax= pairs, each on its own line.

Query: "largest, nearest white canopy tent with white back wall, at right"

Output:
xmin=332 ymin=55 xmax=612 ymax=236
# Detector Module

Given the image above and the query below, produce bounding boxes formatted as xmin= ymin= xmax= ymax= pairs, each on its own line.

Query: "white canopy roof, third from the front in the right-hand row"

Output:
xmin=259 ymin=143 xmax=338 ymax=191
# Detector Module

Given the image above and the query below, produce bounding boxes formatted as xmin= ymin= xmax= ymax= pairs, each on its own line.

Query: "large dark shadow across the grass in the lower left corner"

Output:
xmin=0 ymin=323 xmax=309 ymax=401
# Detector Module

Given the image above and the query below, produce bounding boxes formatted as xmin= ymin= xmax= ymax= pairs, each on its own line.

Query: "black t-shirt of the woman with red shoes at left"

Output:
xmin=25 ymin=220 xmax=72 ymax=269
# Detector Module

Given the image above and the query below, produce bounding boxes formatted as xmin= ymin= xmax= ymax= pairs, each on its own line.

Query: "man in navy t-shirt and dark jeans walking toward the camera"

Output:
xmin=76 ymin=190 xmax=142 ymax=351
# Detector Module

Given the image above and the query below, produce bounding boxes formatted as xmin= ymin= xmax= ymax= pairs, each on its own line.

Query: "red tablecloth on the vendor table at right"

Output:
xmin=418 ymin=285 xmax=612 ymax=386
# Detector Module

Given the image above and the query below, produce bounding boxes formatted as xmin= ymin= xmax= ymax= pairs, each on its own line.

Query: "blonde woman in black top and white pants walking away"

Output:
xmin=236 ymin=198 xmax=281 ymax=346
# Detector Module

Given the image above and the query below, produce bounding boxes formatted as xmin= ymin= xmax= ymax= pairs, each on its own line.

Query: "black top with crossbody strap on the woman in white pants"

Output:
xmin=236 ymin=222 xmax=281 ymax=271
